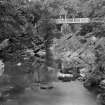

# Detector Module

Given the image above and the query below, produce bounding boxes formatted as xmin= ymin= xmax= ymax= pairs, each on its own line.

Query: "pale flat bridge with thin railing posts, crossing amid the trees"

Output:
xmin=54 ymin=16 xmax=105 ymax=32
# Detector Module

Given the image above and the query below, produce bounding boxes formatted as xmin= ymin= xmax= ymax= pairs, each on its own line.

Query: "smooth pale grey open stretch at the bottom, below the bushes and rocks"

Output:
xmin=4 ymin=81 xmax=97 ymax=105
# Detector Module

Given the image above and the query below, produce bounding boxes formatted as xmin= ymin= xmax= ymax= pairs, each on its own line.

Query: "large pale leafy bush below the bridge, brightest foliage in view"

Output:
xmin=53 ymin=34 xmax=96 ymax=68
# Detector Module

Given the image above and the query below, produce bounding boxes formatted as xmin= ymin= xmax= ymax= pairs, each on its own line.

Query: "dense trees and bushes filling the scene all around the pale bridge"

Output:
xmin=0 ymin=0 xmax=105 ymax=104
